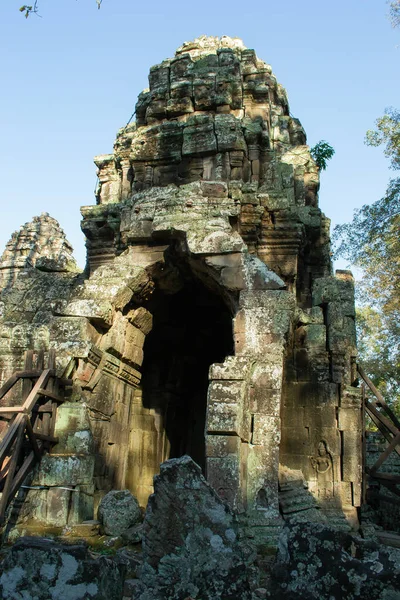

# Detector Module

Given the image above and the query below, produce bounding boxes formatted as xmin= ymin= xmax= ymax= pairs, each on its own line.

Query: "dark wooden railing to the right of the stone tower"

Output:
xmin=357 ymin=365 xmax=400 ymax=504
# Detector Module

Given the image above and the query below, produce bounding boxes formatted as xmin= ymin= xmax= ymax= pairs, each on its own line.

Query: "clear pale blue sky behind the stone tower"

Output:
xmin=0 ymin=0 xmax=400 ymax=266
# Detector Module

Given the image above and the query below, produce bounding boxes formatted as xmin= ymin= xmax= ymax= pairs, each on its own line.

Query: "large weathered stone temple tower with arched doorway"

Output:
xmin=0 ymin=36 xmax=362 ymax=531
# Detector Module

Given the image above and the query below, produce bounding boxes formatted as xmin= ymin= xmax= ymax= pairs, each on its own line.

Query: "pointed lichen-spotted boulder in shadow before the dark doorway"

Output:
xmin=136 ymin=456 xmax=253 ymax=600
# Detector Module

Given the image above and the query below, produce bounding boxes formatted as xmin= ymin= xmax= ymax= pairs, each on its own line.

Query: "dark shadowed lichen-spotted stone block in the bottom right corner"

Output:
xmin=269 ymin=523 xmax=400 ymax=600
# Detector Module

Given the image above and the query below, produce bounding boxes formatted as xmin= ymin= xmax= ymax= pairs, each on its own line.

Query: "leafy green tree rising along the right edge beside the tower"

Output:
xmin=334 ymin=108 xmax=400 ymax=409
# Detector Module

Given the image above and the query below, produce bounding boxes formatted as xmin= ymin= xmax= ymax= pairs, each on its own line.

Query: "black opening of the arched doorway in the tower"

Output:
xmin=142 ymin=277 xmax=234 ymax=470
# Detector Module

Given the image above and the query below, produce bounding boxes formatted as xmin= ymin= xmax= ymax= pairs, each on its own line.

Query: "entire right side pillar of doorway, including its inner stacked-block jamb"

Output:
xmin=207 ymin=290 xmax=295 ymax=544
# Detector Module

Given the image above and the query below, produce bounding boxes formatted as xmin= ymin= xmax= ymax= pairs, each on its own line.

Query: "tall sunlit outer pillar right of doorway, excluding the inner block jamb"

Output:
xmin=228 ymin=290 xmax=295 ymax=547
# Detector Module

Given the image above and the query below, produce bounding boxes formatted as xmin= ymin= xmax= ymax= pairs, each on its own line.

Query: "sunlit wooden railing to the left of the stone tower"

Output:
xmin=0 ymin=350 xmax=71 ymax=525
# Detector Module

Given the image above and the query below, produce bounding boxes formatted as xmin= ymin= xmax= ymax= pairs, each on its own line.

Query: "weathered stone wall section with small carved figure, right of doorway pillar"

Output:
xmin=280 ymin=271 xmax=363 ymax=518
